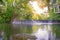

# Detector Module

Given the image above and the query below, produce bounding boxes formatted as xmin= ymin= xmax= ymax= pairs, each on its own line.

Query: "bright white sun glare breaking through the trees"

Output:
xmin=29 ymin=1 xmax=48 ymax=14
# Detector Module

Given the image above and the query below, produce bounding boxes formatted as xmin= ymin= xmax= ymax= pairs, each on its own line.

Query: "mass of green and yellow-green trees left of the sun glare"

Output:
xmin=0 ymin=0 xmax=32 ymax=23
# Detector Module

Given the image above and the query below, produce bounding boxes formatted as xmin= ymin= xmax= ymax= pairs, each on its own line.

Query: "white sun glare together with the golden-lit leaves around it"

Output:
xmin=29 ymin=0 xmax=49 ymax=19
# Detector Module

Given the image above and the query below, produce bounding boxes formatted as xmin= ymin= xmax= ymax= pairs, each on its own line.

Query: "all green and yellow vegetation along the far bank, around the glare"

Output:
xmin=0 ymin=0 xmax=60 ymax=23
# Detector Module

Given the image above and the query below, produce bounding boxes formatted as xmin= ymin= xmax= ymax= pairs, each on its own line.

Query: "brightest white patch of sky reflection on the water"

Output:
xmin=32 ymin=24 xmax=49 ymax=40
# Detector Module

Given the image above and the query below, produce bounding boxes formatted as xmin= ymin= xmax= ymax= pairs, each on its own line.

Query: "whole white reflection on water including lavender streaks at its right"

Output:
xmin=32 ymin=22 xmax=56 ymax=40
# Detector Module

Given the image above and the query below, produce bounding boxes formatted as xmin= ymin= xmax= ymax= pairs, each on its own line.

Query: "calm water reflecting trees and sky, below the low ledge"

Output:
xmin=0 ymin=23 xmax=60 ymax=40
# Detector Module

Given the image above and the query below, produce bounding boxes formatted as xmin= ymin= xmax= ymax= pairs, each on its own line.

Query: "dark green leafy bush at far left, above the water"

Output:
xmin=0 ymin=5 xmax=14 ymax=23
